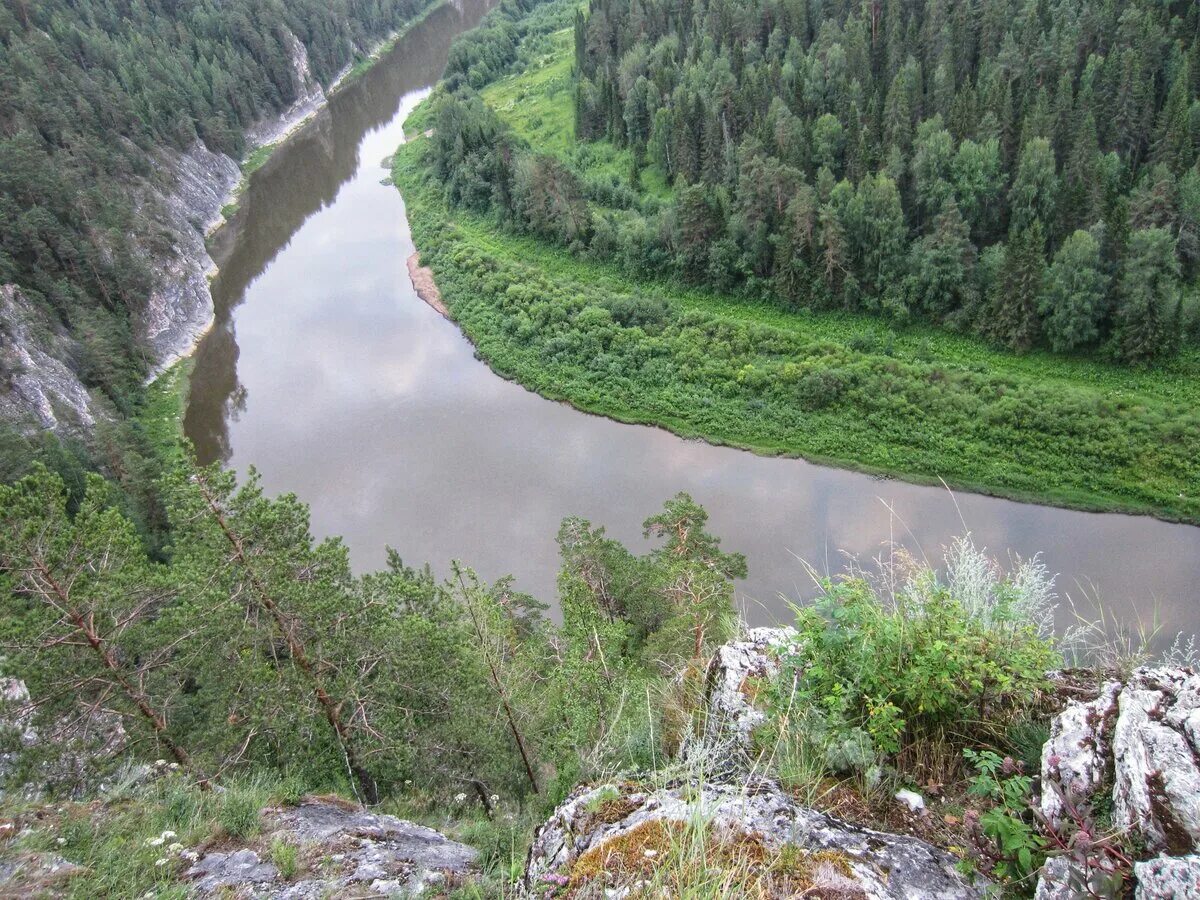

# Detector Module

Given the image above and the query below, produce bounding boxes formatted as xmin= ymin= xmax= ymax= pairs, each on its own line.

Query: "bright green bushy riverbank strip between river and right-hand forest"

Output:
xmin=392 ymin=139 xmax=1200 ymax=522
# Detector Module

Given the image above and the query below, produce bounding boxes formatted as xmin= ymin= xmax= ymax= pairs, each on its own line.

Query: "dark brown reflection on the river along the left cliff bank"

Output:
xmin=184 ymin=0 xmax=492 ymax=463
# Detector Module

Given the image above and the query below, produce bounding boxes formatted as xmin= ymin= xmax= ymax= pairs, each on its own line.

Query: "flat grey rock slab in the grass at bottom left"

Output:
xmin=187 ymin=799 xmax=478 ymax=900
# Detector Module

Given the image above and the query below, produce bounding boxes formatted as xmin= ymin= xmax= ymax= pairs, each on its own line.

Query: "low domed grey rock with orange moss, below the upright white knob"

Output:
xmin=523 ymin=779 xmax=988 ymax=900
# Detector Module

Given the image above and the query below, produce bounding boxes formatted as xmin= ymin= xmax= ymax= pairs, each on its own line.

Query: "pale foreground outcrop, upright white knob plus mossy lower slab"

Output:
xmin=523 ymin=629 xmax=989 ymax=900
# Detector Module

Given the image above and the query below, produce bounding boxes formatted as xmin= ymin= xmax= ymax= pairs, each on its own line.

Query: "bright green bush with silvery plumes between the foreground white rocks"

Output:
xmin=773 ymin=541 xmax=1058 ymax=774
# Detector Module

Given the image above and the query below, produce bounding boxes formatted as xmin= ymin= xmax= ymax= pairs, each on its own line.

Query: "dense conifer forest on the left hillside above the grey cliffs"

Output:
xmin=0 ymin=0 xmax=425 ymax=413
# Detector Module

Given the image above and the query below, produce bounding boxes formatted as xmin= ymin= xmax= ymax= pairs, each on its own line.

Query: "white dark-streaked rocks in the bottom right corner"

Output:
xmin=1038 ymin=668 xmax=1200 ymax=900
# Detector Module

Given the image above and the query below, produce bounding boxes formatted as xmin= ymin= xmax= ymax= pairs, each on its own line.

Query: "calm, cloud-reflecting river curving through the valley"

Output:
xmin=185 ymin=0 xmax=1200 ymax=635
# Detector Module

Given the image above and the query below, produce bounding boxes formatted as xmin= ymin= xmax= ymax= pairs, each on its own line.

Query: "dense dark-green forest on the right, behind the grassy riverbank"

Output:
xmin=436 ymin=0 xmax=1200 ymax=362
